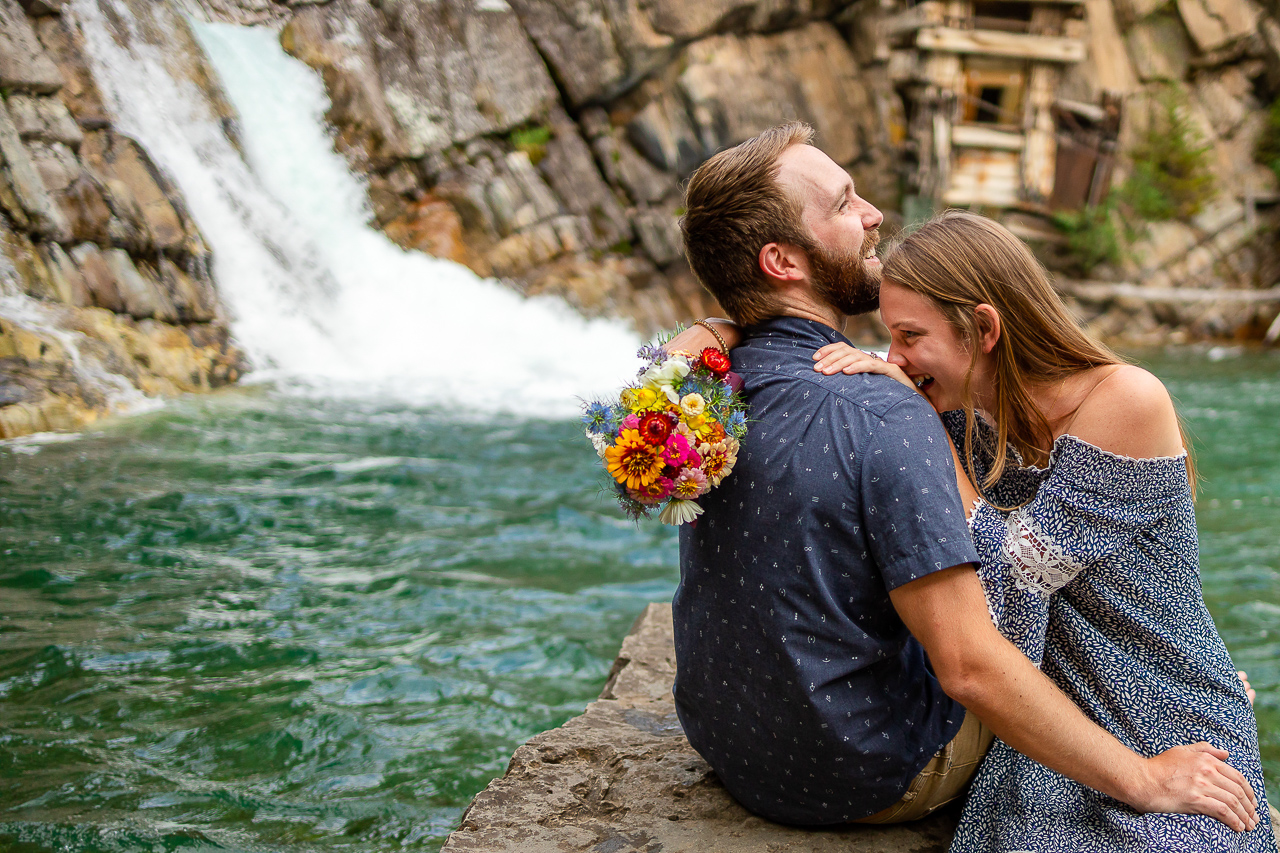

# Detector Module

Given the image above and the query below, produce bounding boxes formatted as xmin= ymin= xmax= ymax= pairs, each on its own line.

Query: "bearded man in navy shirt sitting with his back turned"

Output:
xmin=673 ymin=123 xmax=1257 ymax=830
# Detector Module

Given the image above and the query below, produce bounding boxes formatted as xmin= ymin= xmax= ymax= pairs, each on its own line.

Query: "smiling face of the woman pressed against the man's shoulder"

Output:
xmin=881 ymin=279 xmax=983 ymax=411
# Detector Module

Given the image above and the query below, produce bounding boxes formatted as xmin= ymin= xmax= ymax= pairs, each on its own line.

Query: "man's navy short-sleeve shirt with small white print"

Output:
xmin=672 ymin=318 xmax=977 ymax=825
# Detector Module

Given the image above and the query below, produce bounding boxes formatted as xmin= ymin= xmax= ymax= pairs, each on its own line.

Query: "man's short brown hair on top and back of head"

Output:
xmin=680 ymin=122 xmax=813 ymax=325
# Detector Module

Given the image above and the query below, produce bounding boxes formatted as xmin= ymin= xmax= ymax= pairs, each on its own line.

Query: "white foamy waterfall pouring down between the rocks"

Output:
xmin=72 ymin=0 xmax=640 ymax=416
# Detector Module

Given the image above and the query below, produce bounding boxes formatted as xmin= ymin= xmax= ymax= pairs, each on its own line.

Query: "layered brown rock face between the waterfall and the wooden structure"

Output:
xmin=262 ymin=0 xmax=896 ymax=332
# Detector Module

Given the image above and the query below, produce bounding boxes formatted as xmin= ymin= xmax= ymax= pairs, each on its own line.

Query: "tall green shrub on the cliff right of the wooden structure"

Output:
xmin=1119 ymin=87 xmax=1215 ymax=220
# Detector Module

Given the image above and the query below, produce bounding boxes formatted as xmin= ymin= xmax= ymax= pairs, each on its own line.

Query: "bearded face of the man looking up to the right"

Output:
xmin=778 ymin=145 xmax=883 ymax=314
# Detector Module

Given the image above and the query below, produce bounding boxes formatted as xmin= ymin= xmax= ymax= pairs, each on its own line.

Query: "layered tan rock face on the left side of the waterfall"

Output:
xmin=0 ymin=0 xmax=243 ymax=438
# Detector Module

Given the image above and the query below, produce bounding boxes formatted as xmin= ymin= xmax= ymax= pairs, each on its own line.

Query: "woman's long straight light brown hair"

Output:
xmin=883 ymin=210 xmax=1152 ymax=492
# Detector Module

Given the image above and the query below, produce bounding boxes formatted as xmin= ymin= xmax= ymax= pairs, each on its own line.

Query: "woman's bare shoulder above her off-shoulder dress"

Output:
xmin=1070 ymin=364 xmax=1183 ymax=459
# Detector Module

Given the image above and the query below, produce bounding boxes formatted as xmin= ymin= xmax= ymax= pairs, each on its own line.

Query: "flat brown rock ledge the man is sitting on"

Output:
xmin=442 ymin=605 xmax=956 ymax=853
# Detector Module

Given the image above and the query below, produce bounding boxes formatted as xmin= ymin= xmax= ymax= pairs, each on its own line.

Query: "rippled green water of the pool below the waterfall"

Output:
xmin=0 ymin=352 xmax=1280 ymax=852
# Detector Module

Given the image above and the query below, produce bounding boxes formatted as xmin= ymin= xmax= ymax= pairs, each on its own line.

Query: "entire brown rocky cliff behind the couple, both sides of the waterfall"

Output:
xmin=0 ymin=0 xmax=1280 ymax=437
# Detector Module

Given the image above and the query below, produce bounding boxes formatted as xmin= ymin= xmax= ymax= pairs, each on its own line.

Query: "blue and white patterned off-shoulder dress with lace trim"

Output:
xmin=943 ymin=412 xmax=1276 ymax=853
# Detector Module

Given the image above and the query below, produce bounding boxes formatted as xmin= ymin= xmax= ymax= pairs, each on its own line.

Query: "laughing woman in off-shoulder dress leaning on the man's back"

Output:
xmin=675 ymin=211 xmax=1275 ymax=853
